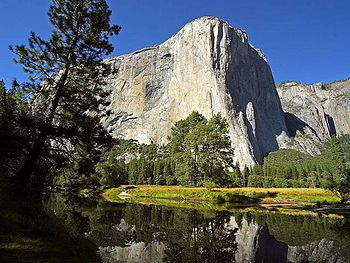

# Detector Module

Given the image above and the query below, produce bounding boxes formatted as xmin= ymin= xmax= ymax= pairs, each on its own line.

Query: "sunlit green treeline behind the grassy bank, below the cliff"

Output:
xmin=52 ymin=109 xmax=350 ymax=200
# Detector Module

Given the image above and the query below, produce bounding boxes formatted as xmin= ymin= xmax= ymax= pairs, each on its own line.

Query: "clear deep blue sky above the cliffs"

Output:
xmin=0 ymin=0 xmax=350 ymax=86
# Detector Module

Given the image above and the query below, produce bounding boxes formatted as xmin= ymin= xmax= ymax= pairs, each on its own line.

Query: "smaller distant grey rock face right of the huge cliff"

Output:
xmin=277 ymin=79 xmax=350 ymax=154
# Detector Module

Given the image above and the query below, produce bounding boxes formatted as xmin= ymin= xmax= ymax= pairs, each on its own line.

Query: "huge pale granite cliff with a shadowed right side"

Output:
xmin=104 ymin=17 xmax=289 ymax=165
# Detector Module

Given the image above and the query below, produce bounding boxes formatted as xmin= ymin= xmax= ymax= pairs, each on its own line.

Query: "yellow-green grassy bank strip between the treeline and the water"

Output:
xmin=103 ymin=185 xmax=339 ymax=203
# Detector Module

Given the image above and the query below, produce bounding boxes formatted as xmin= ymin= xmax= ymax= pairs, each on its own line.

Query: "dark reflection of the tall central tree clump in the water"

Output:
xmin=165 ymin=210 xmax=237 ymax=262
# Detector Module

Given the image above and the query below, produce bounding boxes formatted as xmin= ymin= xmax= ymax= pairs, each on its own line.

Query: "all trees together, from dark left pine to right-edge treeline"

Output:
xmin=0 ymin=0 xmax=350 ymax=203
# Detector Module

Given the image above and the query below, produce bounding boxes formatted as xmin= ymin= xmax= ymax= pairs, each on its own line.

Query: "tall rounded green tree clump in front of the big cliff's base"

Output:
xmin=169 ymin=112 xmax=232 ymax=185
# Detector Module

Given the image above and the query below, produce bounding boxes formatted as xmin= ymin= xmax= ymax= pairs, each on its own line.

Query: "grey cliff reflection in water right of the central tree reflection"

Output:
xmin=227 ymin=217 xmax=349 ymax=263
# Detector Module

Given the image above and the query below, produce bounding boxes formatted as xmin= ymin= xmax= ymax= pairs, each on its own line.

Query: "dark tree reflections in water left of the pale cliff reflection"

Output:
xmin=46 ymin=194 xmax=237 ymax=262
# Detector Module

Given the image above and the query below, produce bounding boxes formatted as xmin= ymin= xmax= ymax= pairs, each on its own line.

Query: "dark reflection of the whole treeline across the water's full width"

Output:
xmin=45 ymin=194 xmax=350 ymax=262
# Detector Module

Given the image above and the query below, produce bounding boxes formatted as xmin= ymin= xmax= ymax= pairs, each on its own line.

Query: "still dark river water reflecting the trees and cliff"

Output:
xmin=45 ymin=194 xmax=350 ymax=263
